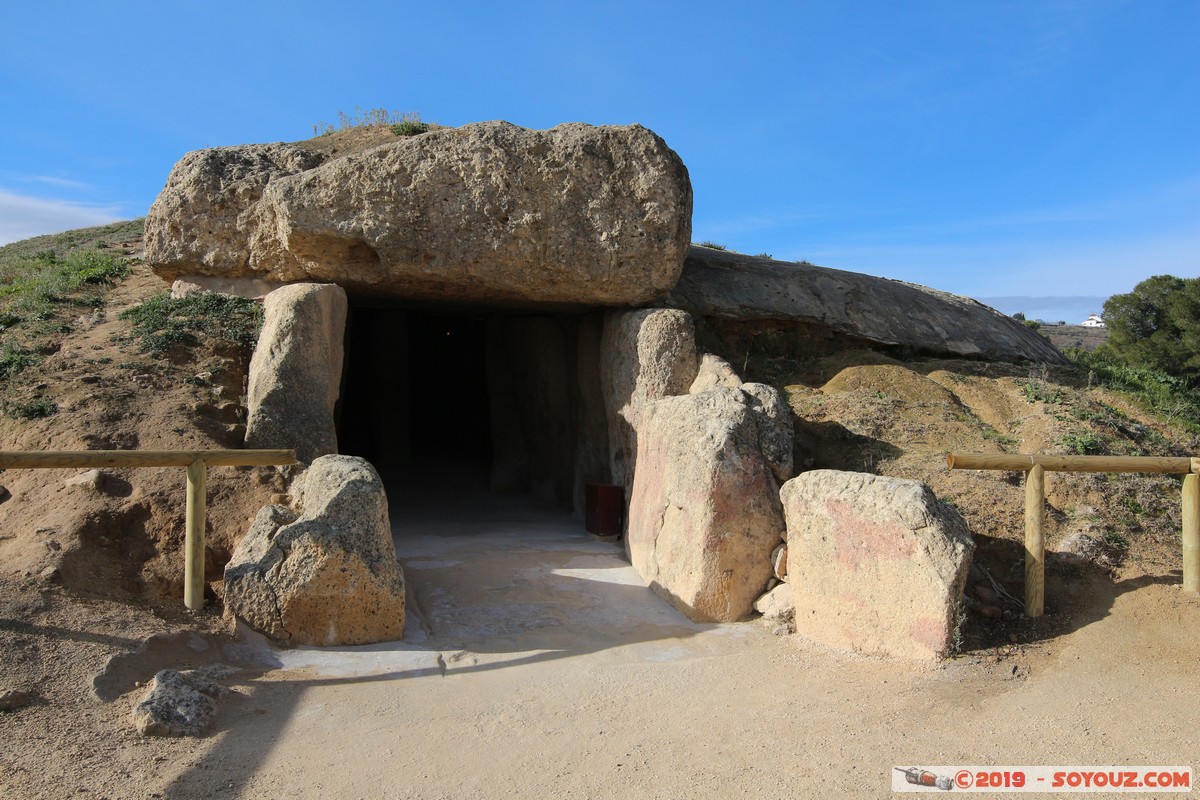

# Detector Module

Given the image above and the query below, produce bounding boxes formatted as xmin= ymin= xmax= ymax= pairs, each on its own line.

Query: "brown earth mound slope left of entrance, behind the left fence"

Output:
xmin=0 ymin=223 xmax=280 ymax=606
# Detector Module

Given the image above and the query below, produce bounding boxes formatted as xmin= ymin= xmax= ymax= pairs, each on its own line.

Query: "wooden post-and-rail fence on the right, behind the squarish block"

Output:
xmin=946 ymin=453 xmax=1200 ymax=616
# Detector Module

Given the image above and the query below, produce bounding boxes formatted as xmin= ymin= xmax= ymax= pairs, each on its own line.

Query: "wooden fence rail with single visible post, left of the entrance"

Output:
xmin=0 ymin=450 xmax=296 ymax=612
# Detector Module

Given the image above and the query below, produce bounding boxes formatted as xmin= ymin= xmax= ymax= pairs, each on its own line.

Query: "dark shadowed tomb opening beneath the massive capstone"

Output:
xmin=338 ymin=306 xmax=608 ymax=510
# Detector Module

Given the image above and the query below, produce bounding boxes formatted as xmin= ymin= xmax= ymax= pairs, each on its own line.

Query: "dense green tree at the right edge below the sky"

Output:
xmin=1104 ymin=275 xmax=1200 ymax=383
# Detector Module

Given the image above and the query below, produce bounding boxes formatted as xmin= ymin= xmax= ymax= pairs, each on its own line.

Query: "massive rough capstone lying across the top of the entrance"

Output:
xmin=145 ymin=121 xmax=691 ymax=306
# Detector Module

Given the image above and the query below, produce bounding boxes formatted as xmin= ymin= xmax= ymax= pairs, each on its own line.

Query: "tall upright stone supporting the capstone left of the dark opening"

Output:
xmin=246 ymin=283 xmax=347 ymax=462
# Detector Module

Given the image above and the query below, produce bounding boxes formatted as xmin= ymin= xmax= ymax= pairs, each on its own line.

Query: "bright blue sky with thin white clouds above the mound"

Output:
xmin=0 ymin=0 xmax=1200 ymax=312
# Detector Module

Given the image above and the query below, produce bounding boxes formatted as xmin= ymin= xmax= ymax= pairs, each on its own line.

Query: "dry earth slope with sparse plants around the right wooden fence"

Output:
xmin=748 ymin=350 xmax=1200 ymax=651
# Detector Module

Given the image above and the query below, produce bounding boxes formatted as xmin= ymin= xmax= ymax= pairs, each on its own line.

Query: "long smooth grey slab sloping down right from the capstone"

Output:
xmin=659 ymin=247 xmax=1066 ymax=363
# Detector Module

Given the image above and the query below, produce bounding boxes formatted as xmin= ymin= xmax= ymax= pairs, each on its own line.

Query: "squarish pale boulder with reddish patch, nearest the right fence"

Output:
xmin=781 ymin=469 xmax=974 ymax=658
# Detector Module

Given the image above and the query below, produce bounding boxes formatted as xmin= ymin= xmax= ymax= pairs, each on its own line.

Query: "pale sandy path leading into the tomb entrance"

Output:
xmin=63 ymin=489 xmax=1200 ymax=799
